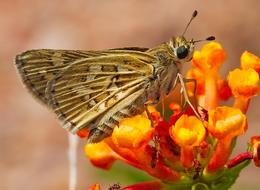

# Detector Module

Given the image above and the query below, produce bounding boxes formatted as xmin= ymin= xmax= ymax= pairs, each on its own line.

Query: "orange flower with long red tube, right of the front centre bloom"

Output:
xmin=208 ymin=106 xmax=247 ymax=172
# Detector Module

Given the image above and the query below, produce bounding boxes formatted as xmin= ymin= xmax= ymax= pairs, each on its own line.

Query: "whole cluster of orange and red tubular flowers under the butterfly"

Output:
xmin=84 ymin=42 xmax=260 ymax=190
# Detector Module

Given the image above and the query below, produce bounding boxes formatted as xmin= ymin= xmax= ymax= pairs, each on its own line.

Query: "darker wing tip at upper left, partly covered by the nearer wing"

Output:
xmin=16 ymin=49 xmax=104 ymax=104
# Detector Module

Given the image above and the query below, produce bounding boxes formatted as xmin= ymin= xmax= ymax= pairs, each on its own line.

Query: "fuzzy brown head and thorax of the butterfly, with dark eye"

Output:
xmin=149 ymin=37 xmax=194 ymax=101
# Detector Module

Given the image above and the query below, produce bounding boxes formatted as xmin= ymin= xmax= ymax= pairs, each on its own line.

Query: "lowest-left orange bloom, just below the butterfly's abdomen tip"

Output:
xmin=85 ymin=141 xmax=118 ymax=169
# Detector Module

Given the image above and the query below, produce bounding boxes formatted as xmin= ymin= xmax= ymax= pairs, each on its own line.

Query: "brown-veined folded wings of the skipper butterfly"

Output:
xmin=16 ymin=49 xmax=157 ymax=141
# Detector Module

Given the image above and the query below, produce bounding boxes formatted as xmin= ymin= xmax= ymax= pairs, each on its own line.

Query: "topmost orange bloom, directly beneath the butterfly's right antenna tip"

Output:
xmin=192 ymin=42 xmax=226 ymax=71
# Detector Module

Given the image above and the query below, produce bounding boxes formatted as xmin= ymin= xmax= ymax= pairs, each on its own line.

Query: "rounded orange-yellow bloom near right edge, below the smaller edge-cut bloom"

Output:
xmin=228 ymin=68 xmax=259 ymax=98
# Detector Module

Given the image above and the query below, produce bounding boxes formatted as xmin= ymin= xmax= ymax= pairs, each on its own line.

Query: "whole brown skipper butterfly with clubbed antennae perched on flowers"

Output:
xmin=15 ymin=11 xmax=214 ymax=143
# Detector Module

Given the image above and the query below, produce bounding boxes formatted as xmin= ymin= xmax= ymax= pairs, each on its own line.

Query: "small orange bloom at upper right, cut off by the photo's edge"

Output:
xmin=240 ymin=51 xmax=260 ymax=74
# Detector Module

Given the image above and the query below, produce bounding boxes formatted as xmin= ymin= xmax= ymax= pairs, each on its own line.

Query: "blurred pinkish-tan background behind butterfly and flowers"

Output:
xmin=0 ymin=0 xmax=260 ymax=190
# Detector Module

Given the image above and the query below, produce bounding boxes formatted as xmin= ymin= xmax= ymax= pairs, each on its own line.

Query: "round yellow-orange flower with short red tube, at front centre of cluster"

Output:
xmin=170 ymin=114 xmax=206 ymax=168
